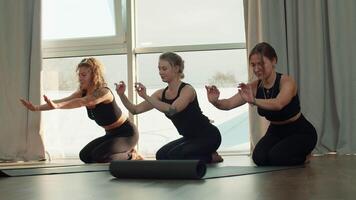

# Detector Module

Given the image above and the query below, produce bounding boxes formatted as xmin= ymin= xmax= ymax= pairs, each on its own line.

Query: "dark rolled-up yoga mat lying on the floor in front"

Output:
xmin=109 ymin=160 xmax=206 ymax=179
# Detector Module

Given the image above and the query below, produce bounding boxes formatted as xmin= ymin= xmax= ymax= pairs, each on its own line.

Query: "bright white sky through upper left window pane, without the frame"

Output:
xmin=42 ymin=0 xmax=116 ymax=40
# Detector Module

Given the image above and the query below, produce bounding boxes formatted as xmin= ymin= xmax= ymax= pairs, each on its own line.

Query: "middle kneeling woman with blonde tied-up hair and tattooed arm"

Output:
xmin=116 ymin=52 xmax=222 ymax=163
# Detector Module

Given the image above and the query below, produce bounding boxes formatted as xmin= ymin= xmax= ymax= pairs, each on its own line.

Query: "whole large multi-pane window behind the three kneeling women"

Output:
xmin=42 ymin=0 xmax=249 ymax=158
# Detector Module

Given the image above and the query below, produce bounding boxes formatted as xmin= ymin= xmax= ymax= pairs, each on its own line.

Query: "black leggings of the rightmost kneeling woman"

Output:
xmin=252 ymin=115 xmax=318 ymax=166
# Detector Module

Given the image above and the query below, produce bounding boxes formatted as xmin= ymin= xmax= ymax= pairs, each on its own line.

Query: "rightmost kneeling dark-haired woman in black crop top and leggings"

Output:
xmin=206 ymin=42 xmax=317 ymax=166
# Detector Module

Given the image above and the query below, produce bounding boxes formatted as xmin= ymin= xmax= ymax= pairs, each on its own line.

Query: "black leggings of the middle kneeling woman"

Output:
xmin=156 ymin=126 xmax=221 ymax=163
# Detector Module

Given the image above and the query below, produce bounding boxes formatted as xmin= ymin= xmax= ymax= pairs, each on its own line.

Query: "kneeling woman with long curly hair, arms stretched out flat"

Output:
xmin=21 ymin=58 xmax=142 ymax=163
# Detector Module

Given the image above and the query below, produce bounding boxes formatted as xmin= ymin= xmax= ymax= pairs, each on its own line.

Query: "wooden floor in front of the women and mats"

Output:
xmin=0 ymin=155 xmax=356 ymax=200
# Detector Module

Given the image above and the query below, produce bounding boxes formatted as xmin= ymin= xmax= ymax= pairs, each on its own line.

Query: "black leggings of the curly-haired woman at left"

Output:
xmin=79 ymin=120 xmax=138 ymax=163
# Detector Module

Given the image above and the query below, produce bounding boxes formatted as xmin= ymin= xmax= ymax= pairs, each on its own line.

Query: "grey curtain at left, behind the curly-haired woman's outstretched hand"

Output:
xmin=0 ymin=0 xmax=45 ymax=161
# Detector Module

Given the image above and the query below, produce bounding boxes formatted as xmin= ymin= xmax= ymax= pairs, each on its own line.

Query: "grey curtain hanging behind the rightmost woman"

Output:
xmin=244 ymin=0 xmax=356 ymax=154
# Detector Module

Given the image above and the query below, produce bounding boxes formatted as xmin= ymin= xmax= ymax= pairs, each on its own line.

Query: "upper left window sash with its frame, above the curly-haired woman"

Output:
xmin=42 ymin=0 xmax=125 ymax=57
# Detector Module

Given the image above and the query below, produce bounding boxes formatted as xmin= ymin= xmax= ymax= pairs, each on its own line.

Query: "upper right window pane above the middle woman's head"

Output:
xmin=136 ymin=0 xmax=245 ymax=47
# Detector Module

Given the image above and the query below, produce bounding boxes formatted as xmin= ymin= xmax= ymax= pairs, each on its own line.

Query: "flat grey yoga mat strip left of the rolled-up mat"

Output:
xmin=0 ymin=164 xmax=109 ymax=177
